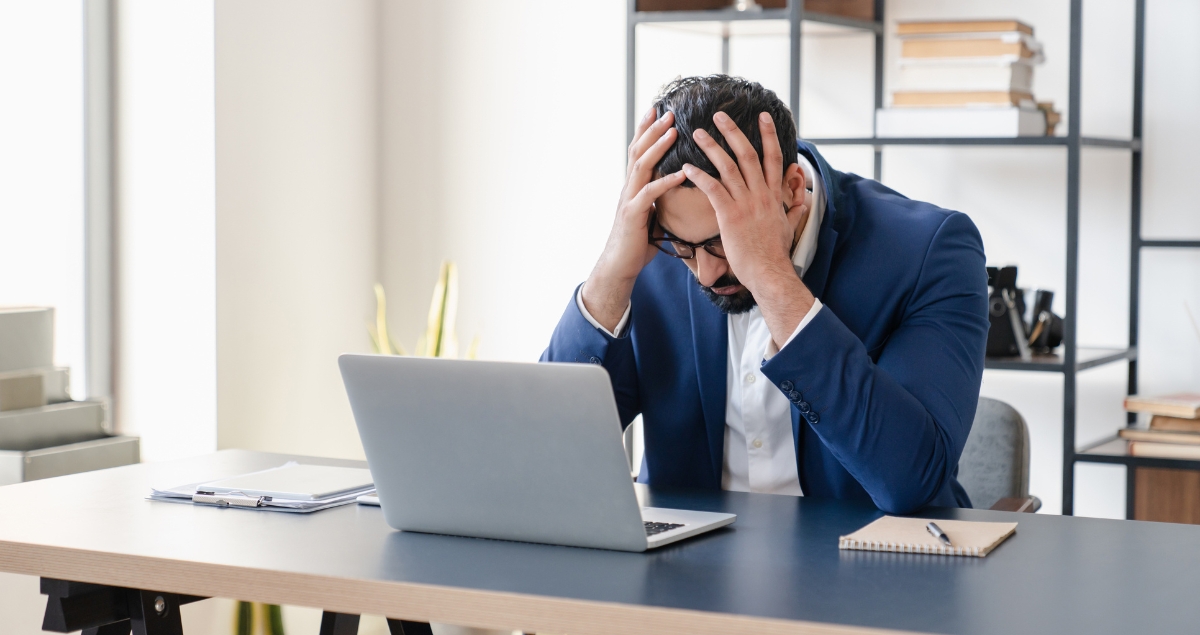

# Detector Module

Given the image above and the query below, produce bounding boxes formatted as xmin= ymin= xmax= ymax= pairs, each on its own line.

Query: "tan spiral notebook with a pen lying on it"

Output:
xmin=838 ymin=516 xmax=1016 ymax=558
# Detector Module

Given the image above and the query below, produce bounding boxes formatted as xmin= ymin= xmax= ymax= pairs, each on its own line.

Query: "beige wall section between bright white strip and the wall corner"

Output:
xmin=216 ymin=0 xmax=379 ymax=457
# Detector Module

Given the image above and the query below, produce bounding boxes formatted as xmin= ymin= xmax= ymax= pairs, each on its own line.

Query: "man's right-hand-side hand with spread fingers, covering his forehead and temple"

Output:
xmin=683 ymin=113 xmax=814 ymax=348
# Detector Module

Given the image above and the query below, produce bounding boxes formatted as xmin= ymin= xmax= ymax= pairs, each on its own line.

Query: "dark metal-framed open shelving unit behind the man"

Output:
xmin=625 ymin=0 xmax=1200 ymax=517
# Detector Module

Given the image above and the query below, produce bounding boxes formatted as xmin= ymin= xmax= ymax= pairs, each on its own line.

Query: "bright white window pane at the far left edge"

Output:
xmin=0 ymin=2 xmax=86 ymax=399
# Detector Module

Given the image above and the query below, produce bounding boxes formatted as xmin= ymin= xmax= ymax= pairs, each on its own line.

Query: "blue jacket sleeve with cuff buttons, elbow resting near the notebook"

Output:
xmin=762 ymin=214 xmax=988 ymax=513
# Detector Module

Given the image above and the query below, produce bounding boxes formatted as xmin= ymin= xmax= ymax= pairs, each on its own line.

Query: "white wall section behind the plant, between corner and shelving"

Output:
xmin=382 ymin=0 xmax=625 ymax=360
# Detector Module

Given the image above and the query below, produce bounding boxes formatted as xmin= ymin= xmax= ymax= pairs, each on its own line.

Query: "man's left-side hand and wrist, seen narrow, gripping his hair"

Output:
xmin=583 ymin=108 xmax=684 ymax=333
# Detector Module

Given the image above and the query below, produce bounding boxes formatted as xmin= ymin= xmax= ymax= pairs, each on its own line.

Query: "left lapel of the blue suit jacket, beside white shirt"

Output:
xmin=688 ymin=272 xmax=730 ymax=487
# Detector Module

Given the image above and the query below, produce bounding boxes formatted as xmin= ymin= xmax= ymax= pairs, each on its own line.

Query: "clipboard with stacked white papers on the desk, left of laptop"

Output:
xmin=148 ymin=461 xmax=374 ymax=514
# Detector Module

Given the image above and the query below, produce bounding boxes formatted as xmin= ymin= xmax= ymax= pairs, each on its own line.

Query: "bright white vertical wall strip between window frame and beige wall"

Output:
xmin=115 ymin=0 xmax=217 ymax=461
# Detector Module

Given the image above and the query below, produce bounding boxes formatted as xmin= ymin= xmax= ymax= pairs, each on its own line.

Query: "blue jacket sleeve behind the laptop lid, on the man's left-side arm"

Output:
xmin=541 ymin=288 xmax=641 ymax=427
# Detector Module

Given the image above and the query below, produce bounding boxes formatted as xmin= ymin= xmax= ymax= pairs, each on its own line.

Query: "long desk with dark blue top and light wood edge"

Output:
xmin=0 ymin=450 xmax=1200 ymax=635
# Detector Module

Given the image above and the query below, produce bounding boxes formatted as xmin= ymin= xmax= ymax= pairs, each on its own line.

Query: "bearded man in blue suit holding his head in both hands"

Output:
xmin=542 ymin=76 xmax=988 ymax=513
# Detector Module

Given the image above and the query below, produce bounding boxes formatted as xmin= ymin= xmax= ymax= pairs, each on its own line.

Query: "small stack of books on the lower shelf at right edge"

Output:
xmin=1118 ymin=393 xmax=1200 ymax=460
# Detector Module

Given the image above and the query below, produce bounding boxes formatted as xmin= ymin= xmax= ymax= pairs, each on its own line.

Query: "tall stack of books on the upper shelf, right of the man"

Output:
xmin=876 ymin=19 xmax=1060 ymax=137
